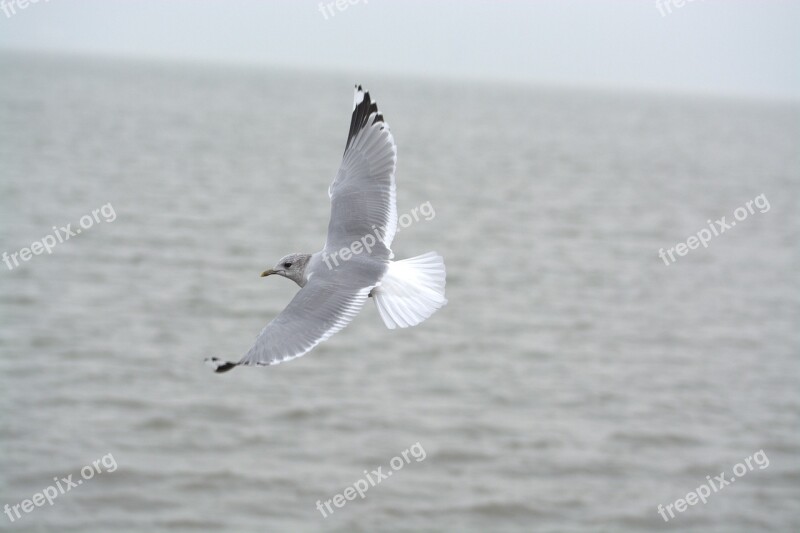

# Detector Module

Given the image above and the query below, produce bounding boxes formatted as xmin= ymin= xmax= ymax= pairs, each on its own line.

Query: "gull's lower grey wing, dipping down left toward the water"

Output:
xmin=207 ymin=257 xmax=386 ymax=372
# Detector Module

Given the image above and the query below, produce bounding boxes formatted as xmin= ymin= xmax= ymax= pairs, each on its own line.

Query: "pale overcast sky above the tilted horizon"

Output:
xmin=0 ymin=0 xmax=800 ymax=99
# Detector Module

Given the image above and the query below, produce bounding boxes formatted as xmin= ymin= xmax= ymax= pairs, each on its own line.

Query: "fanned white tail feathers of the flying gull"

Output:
xmin=372 ymin=252 xmax=447 ymax=329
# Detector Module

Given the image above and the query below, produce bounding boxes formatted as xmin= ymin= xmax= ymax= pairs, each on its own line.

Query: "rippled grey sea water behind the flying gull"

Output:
xmin=0 ymin=54 xmax=800 ymax=532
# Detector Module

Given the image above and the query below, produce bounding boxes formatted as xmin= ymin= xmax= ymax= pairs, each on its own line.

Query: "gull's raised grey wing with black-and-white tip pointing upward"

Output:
xmin=325 ymin=85 xmax=397 ymax=259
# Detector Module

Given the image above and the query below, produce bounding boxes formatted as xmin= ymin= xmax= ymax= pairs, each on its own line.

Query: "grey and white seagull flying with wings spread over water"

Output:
xmin=206 ymin=85 xmax=447 ymax=372
